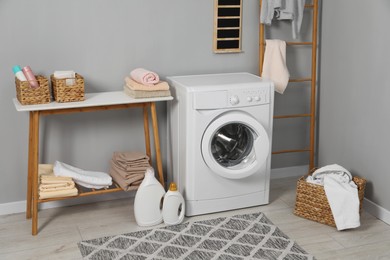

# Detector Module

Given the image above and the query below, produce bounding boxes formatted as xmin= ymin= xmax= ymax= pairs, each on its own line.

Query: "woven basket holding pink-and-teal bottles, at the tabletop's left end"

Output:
xmin=15 ymin=75 xmax=50 ymax=105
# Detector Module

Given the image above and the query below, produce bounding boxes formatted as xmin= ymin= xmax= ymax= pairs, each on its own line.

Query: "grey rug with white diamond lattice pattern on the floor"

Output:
xmin=78 ymin=213 xmax=315 ymax=260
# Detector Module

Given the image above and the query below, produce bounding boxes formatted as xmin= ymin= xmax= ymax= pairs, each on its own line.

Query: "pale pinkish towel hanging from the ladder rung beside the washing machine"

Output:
xmin=261 ymin=40 xmax=290 ymax=94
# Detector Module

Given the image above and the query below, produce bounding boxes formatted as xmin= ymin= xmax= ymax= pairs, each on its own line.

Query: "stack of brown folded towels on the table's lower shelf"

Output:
xmin=110 ymin=152 xmax=151 ymax=191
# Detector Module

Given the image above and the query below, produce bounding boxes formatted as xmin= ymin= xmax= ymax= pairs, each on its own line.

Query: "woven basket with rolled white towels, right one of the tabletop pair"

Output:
xmin=50 ymin=73 xmax=85 ymax=103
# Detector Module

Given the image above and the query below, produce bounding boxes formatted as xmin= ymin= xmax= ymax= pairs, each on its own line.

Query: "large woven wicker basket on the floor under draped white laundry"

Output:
xmin=294 ymin=173 xmax=366 ymax=227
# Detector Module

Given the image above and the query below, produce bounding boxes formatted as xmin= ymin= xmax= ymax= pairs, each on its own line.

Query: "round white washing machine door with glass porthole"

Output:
xmin=201 ymin=111 xmax=270 ymax=179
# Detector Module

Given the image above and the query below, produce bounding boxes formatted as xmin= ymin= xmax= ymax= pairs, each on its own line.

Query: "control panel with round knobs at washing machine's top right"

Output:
xmin=228 ymin=88 xmax=269 ymax=107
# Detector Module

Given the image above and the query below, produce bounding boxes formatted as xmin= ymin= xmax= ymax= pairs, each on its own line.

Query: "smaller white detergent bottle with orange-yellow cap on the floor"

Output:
xmin=163 ymin=182 xmax=185 ymax=225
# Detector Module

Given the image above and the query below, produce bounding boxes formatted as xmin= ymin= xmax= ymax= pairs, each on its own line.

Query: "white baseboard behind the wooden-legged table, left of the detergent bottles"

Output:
xmin=0 ymin=192 xmax=135 ymax=216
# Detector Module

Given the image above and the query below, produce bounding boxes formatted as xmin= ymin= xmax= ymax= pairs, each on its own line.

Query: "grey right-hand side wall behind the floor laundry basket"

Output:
xmin=319 ymin=0 xmax=390 ymax=210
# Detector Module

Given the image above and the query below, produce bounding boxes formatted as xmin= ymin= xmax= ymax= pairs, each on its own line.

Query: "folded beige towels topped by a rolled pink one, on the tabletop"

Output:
xmin=123 ymin=68 xmax=171 ymax=98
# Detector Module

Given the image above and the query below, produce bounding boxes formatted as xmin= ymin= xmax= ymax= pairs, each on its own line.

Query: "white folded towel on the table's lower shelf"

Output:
xmin=53 ymin=161 xmax=112 ymax=189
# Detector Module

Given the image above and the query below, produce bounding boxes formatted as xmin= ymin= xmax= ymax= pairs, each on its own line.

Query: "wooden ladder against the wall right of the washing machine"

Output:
xmin=259 ymin=0 xmax=318 ymax=170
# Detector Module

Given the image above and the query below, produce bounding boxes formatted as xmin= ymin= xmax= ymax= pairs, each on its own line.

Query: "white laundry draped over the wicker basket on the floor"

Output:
xmin=307 ymin=164 xmax=360 ymax=230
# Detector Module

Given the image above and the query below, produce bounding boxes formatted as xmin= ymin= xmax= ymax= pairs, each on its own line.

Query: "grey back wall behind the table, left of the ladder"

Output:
xmin=0 ymin=0 xmax=266 ymax=203
